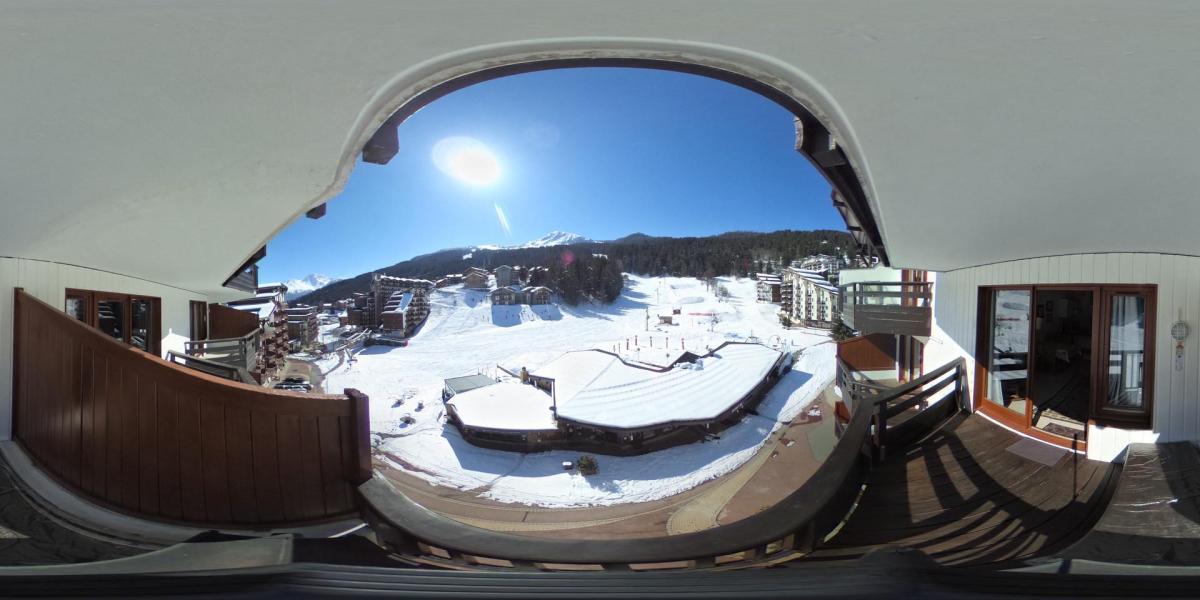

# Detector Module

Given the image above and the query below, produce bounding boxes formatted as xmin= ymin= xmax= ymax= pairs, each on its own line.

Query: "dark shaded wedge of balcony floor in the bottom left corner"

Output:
xmin=0 ymin=463 xmax=145 ymax=566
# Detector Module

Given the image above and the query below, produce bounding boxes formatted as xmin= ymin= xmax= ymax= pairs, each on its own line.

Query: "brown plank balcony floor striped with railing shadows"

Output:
xmin=809 ymin=415 xmax=1120 ymax=565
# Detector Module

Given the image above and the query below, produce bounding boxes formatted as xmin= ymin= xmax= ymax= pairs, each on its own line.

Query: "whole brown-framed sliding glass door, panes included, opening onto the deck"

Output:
xmin=976 ymin=284 xmax=1156 ymax=445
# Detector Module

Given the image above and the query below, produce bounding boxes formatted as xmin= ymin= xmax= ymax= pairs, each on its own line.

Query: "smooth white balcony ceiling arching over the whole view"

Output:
xmin=0 ymin=0 xmax=1200 ymax=290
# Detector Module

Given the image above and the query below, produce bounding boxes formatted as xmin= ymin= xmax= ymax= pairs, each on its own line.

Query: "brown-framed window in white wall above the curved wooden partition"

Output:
xmin=65 ymin=289 xmax=162 ymax=354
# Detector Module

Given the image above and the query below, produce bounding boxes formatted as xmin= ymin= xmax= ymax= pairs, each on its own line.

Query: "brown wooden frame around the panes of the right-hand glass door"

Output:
xmin=972 ymin=283 xmax=1158 ymax=451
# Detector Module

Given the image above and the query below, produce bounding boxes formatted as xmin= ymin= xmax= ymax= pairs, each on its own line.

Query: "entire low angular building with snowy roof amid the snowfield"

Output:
xmin=446 ymin=342 xmax=790 ymax=455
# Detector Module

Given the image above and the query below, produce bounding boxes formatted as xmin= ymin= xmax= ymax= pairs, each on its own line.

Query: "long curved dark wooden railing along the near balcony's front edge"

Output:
xmin=359 ymin=360 xmax=965 ymax=571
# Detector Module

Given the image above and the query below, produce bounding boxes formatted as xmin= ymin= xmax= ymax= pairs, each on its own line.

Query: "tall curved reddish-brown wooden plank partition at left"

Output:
xmin=13 ymin=288 xmax=371 ymax=528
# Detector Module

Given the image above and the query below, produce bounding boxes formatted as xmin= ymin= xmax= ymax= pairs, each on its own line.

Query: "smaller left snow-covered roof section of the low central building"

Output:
xmin=446 ymin=380 xmax=558 ymax=431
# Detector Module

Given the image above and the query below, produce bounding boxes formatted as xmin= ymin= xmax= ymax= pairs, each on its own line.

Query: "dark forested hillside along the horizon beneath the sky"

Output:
xmin=295 ymin=229 xmax=857 ymax=304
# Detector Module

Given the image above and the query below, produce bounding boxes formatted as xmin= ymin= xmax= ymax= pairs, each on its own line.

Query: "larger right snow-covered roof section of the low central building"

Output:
xmin=534 ymin=343 xmax=781 ymax=430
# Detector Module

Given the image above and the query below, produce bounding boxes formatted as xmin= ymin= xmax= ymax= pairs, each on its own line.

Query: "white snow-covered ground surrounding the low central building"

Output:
xmin=318 ymin=276 xmax=834 ymax=506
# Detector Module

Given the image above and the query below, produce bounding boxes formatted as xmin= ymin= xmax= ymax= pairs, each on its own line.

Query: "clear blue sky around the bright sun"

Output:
xmin=260 ymin=68 xmax=845 ymax=281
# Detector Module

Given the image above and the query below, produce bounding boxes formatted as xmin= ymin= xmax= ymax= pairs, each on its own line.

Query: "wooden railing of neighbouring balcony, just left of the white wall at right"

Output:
xmin=839 ymin=281 xmax=932 ymax=336
